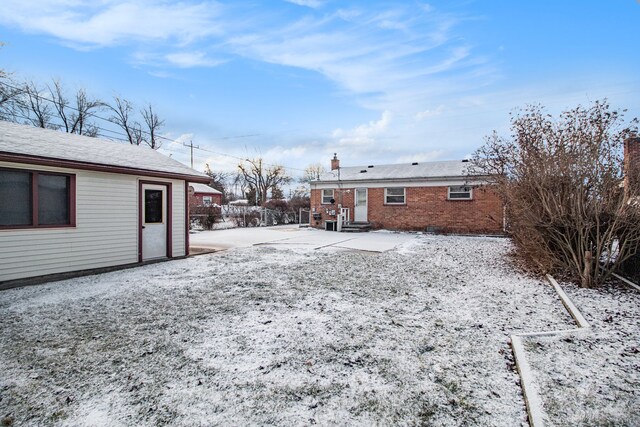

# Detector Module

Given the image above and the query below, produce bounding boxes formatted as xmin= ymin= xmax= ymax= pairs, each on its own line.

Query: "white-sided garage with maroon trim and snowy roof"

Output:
xmin=0 ymin=122 xmax=209 ymax=285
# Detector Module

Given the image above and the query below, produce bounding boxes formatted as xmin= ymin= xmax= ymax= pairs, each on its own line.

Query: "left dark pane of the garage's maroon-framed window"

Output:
xmin=0 ymin=170 xmax=31 ymax=225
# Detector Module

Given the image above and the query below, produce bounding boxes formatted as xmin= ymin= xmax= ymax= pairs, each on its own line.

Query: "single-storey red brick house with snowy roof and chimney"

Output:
xmin=311 ymin=156 xmax=504 ymax=234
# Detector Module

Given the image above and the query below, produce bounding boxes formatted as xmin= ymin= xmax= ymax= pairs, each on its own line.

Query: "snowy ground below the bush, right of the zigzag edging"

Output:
xmin=526 ymin=283 xmax=640 ymax=427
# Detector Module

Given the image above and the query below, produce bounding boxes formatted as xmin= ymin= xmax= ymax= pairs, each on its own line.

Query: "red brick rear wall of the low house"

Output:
xmin=311 ymin=187 xmax=503 ymax=233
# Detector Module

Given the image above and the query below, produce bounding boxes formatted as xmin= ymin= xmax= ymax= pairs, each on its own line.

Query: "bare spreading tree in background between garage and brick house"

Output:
xmin=238 ymin=158 xmax=291 ymax=206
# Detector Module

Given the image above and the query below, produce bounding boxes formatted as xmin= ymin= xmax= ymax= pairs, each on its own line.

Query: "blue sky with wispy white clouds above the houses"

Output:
xmin=0 ymin=0 xmax=640 ymax=175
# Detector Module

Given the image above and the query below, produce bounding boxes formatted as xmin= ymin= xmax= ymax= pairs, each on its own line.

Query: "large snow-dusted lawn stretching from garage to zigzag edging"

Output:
xmin=0 ymin=233 xmax=638 ymax=426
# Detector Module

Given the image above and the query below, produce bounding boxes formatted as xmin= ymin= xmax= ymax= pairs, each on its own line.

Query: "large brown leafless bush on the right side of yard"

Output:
xmin=474 ymin=101 xmax=640 ymax=287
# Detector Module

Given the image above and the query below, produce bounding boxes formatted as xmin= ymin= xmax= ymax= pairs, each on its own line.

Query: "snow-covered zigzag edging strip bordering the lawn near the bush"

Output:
xmin=511 ymin=274 xmax=590 ymax=427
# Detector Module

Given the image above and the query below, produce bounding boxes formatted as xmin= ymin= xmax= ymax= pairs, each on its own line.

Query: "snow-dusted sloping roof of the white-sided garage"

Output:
xmin=0 ymin=121 xmax=209 ymax=182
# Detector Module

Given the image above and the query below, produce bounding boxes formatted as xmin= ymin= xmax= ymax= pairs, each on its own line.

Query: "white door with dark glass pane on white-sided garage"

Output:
xmin=142 ymin=184 xmax=167 ymax=261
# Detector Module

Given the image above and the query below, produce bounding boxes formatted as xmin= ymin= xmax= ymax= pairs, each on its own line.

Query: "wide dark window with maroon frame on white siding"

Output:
xmin=0 ymin=169 xmax=75 ymax=228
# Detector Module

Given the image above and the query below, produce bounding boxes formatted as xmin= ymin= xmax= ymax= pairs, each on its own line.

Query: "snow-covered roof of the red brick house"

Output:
xmin=312 ymin=160 xmax=470 ymax=182
